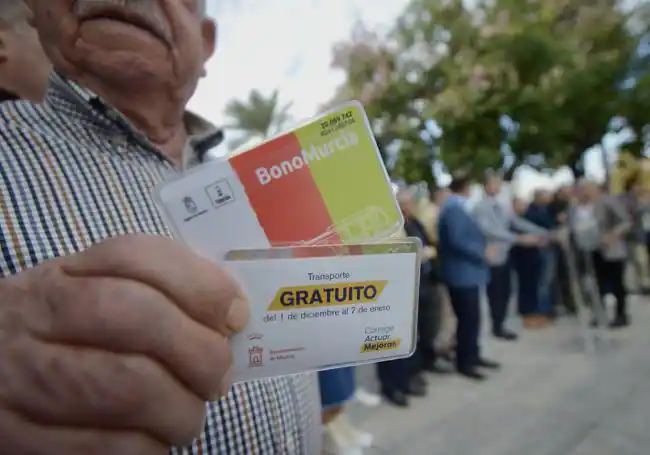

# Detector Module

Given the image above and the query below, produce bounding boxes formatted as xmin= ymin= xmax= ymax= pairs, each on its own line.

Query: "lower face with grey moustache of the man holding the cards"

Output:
xmin=29 ymin=0 xmax=216 ymax=98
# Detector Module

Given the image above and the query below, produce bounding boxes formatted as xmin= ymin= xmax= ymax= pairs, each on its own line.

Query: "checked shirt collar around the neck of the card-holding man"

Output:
xmin=45 ymin=72 xmax=223 ymax=168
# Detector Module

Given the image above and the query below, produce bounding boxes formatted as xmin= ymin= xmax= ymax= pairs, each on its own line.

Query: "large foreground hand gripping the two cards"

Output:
xmin=0 ymin=236 xmax=250 ymax=455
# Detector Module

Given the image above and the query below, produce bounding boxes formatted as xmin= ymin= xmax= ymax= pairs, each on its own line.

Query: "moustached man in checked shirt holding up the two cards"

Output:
xmin=0 ymin=0 xmax=320 ymax=455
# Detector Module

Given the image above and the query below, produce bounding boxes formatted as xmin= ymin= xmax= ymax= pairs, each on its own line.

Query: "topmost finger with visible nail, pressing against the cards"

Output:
xmin=60 ymin=235 xmax=250 ymax=335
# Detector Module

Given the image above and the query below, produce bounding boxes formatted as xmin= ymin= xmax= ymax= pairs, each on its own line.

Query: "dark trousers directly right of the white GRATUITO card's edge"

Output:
xmin=411 ymin=283 xmax=441 ymax=374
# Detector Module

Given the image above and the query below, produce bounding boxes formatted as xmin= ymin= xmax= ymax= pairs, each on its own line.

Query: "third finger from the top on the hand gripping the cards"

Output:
xmin=0 ymin=338 xmax=205 ymax=453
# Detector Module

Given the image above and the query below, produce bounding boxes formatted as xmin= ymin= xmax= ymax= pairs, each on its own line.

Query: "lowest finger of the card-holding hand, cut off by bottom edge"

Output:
xmin=0 ymin=408 xmax=169 ymax=455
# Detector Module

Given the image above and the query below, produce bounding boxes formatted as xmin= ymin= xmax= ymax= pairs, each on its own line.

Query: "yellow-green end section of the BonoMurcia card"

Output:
xmin=294 ymin=102 xmax=402 ymax=243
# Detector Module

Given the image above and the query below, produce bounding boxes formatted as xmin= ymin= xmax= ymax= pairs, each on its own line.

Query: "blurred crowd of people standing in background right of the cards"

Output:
xmin=321 ymin=172 xmax=650 ymax=454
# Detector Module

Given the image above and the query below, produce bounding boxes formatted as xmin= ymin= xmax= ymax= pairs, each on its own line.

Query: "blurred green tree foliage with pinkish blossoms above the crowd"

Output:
xmin=324 ymin=0 xmax=650 ymax=181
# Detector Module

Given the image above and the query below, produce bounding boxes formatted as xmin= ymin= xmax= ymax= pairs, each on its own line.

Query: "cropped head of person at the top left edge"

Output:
xmin=0 ymin=0 xmax=51 ymax=102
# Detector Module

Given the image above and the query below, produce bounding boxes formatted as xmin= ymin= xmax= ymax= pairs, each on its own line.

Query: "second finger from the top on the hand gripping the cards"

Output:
xmin=32 ymin=276 xmax=232 ymax=400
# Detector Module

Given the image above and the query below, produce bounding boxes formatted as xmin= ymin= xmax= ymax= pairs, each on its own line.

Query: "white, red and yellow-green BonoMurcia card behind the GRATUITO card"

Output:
xmin=155 ymin=102 xmax=403 ymax=260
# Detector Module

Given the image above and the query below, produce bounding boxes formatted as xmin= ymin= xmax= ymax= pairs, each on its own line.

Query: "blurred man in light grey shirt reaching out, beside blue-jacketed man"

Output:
xmin=474 ymin=172 xmax=548 ymax=341
